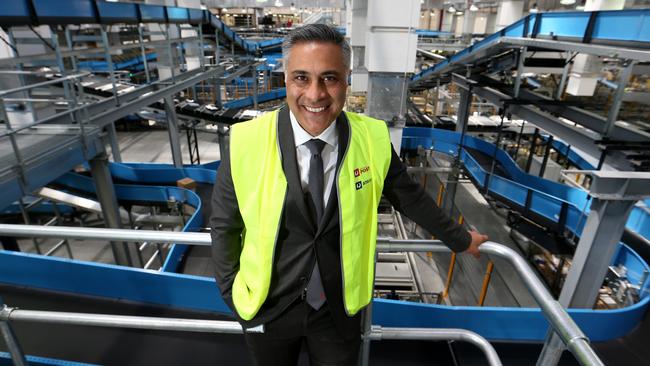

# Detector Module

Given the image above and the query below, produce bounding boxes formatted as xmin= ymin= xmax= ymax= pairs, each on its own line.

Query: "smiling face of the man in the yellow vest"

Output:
xmin=285 ymin=42 xmax=348 ymax=136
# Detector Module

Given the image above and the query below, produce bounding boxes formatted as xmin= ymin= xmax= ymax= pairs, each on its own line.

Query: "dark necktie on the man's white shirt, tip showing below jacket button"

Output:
xmin=305 ymin=139 xmax=325 ymax=310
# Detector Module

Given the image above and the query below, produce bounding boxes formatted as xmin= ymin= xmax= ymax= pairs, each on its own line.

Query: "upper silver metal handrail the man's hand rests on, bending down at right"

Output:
xmin=0 ymin=224 xmax=604 ymax=365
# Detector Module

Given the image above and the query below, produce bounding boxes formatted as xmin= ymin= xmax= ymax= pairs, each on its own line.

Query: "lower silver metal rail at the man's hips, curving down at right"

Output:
xmin=0 ymin=303 xmax=502 ymax=366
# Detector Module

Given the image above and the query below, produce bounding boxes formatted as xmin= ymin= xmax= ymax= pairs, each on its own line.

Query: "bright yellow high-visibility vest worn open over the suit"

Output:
xmin=230 ymin=111 xmax=392 ymax=320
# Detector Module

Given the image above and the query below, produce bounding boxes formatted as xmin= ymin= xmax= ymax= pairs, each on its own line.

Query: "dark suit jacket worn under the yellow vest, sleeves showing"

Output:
xmin=210 ymin=107 xmax=471 ymax=334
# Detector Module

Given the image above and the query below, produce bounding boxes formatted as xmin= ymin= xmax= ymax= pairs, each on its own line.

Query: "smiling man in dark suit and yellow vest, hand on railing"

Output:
xmin=210 ymin=24 xmax=487 ymax=365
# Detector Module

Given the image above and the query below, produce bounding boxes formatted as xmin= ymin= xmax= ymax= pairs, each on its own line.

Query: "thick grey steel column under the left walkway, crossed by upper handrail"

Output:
xmin=90 ymin=154 xmax=137 ymax=266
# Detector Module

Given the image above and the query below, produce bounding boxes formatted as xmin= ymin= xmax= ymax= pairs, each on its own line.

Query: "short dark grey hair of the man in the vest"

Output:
xmin=282 ymin=24 xmax=352 ymax=70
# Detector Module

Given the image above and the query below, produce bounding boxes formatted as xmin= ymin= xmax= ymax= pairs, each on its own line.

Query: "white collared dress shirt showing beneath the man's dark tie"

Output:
xmin=289 ymin=112 xmax=339 ymax=207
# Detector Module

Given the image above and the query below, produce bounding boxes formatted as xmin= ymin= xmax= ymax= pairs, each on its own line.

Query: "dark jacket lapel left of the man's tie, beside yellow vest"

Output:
xmin=278 ymin=105 xmax=316 ymax=231
